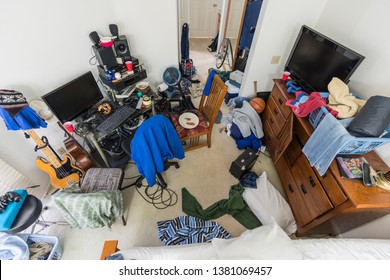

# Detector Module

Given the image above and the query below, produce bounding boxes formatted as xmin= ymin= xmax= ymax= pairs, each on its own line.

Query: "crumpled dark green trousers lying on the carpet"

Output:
xmin=182 ymin=184 xmax=261 ymax=229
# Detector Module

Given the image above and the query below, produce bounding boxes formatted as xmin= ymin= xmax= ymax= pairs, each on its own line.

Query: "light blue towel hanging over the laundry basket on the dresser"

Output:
xmin=302 ymin=114 xmax=354 ymax=176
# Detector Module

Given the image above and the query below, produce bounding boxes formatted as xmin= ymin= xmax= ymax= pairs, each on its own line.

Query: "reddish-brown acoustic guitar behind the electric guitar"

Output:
xmin=57 ymin=122 xmax=96 ymax=172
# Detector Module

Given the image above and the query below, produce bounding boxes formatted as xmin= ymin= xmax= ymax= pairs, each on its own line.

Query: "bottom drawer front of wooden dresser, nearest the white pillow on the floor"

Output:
xmin=275 ymin=157 xmax=314 ymax=227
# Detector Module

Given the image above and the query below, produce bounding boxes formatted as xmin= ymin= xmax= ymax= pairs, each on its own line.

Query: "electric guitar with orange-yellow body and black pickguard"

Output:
xmin=26 ymin=130 xmax=84 ymax=189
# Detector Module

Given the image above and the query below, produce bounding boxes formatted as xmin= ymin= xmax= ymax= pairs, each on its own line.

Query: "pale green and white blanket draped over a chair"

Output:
xmin=52 ymin=185 xmax=123 ymax=228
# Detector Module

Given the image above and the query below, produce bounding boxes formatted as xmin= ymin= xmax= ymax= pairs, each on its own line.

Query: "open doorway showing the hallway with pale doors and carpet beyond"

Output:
xmin=179 ymin=0 xmax=247 ymax=83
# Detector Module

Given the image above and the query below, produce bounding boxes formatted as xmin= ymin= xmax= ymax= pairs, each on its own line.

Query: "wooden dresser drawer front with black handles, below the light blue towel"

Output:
xmin=291 ymin=154 xmax=333 ymax=217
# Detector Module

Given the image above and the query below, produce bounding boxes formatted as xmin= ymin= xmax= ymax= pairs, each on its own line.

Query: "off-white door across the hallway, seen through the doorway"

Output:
xmin=189 ymin=0 xmax=220 ymax=38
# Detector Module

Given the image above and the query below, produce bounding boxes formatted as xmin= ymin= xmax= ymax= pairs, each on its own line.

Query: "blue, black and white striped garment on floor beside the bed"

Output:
xmin=157 ymin=216 xmax=231 ymax=245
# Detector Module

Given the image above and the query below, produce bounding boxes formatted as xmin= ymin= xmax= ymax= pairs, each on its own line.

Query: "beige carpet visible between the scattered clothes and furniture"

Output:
xmin=37 ymin=38 xmax=283 ymax=260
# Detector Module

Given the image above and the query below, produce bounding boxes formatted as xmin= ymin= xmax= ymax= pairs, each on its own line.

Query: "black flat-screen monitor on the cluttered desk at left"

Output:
xmin=42 ymin=71 xmax=103 ymax=123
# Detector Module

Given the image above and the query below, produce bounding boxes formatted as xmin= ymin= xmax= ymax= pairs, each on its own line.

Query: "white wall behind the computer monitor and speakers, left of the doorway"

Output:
xmin=0 ymin=0 xmax=178 ymax=191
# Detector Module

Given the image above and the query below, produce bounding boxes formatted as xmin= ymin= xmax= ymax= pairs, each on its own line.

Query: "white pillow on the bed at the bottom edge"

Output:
xmin=211 ymin=219 xmax=303 ymax=260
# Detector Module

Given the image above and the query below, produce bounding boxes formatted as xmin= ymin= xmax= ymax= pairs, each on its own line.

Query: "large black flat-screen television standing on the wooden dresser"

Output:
xmin=285 ymin=25 xmax=365 ymax=93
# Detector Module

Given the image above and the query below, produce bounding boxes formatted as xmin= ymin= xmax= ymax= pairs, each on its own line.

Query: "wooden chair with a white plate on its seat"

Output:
xmin=170 ymin=75 xmax=228 ymax=151
